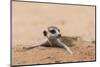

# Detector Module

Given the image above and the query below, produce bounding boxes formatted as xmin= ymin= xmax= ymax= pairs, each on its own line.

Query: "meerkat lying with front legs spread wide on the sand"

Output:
xmin=23 ymin=26 xmax=73 ymax=54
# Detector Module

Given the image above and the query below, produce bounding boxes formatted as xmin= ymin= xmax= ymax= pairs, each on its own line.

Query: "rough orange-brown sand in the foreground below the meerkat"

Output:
xmin=12 ymin=36 xmax=96 ymax=65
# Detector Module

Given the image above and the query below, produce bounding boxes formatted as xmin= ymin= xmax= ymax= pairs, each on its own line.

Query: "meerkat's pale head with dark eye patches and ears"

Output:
xmin=43 ymin=26 xmax=61 ymax=38
